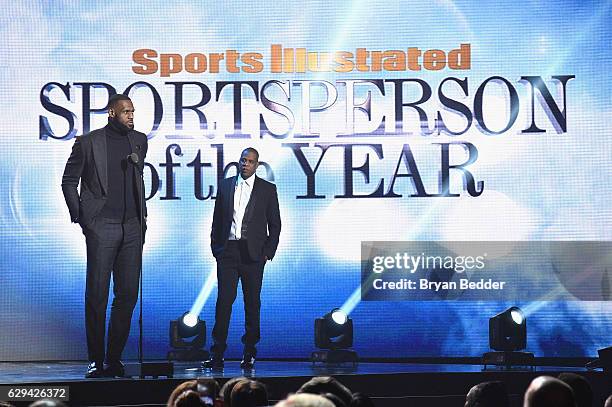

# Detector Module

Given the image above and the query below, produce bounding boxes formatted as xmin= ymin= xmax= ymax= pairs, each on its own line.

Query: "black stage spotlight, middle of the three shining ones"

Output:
xmin=310 ymin=308 xmax=357 ymax=364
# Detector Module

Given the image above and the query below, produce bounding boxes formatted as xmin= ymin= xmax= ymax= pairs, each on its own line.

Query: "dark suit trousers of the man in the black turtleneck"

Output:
xmin=83 ymin=218 xmax=142 ymax=363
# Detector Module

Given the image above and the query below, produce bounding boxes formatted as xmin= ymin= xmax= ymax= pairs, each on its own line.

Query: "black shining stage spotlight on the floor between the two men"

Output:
xmin=168 ymin=312 xmax=209 ymax=360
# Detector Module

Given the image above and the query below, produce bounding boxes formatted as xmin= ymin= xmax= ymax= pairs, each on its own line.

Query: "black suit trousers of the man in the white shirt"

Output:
xmin=211 ymin=240 xmax=266 ymax=356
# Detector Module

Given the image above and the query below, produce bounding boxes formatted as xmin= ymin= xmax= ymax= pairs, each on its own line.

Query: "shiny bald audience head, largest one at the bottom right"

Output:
xmin=523 ymin=376 xmax=576 ymax=407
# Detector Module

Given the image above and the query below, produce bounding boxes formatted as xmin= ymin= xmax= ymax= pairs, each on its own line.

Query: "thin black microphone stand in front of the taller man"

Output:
xmin=125 ymin=153 xmax=174 ymax=379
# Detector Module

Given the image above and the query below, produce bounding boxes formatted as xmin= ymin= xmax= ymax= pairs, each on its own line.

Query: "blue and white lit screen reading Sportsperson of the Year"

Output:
xmin=0 ymin=0 xmax=612 ymax=360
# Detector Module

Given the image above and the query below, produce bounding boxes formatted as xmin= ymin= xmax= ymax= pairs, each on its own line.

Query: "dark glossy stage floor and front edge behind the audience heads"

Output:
xmin=0 ymin=360 xmax=612 ymax=407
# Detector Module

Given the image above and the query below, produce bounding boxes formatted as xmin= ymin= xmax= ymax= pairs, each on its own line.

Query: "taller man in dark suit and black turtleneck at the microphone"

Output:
xmin=62 ymin=95 xmax=147 ymax=378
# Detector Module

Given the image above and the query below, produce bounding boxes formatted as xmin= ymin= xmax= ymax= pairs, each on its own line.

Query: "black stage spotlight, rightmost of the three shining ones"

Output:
xmin=482 ymin=307 xmax=534 ymax=369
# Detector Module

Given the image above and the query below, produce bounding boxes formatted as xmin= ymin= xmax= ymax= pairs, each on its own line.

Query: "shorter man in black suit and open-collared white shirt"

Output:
xmin=202 ymin=148 xmax=281 ymax=369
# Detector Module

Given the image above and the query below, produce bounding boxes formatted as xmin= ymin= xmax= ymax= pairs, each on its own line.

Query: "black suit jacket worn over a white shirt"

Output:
xmin=210 ymin=176 xmax=281 ymax=261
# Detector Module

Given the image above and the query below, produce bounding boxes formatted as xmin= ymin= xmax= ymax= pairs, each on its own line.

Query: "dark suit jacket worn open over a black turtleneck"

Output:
xmin=62 ymin=128 xmax=147 ymax=226
